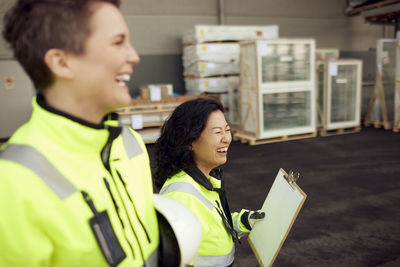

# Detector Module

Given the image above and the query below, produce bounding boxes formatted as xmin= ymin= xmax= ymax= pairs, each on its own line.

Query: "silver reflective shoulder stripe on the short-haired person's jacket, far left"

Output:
xmin=0 ymin=144 xmax=77 ymax=199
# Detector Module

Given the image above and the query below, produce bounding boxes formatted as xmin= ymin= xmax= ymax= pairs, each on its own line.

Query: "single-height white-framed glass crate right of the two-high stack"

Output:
xmin=317 ymin=59 xmax=362 ymax=130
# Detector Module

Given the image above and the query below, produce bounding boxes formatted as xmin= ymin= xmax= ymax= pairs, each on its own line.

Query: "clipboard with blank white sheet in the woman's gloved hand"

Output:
xmin=248 ymin=169 xmax=307 ymax=266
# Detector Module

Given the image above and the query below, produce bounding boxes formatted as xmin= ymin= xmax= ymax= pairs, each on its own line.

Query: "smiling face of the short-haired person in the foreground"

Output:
xmin=69 ymin=2 xmax=140 ymax=115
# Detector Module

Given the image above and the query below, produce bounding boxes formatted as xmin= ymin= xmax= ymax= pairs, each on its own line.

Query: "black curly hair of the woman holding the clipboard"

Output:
xmin=154 ymin=98 xmax=224 ymax=189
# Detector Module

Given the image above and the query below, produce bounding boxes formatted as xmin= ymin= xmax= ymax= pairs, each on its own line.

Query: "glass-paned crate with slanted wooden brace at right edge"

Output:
xmin=364 ymin=39 xmax=400 ymax=132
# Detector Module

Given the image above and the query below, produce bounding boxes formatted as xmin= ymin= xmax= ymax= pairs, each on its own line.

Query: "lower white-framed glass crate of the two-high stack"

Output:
xmin=239 ymin=87 xmax=316 ymax=139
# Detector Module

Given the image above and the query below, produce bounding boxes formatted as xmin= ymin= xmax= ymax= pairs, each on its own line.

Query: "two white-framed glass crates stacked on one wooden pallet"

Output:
xmin=235 ymin=39 xmax=316 ymax=145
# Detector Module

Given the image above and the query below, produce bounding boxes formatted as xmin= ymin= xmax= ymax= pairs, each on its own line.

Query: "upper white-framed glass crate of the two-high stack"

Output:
xmin=240 ymin=39 xmax=315 ymax=90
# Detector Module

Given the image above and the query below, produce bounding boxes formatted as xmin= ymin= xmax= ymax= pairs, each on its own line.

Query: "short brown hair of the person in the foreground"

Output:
xmin=3 ymin=0 xmax=120 ymax=91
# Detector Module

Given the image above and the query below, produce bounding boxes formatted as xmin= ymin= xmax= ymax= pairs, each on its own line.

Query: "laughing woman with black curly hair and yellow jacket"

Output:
xmin=154 ymin=98 xmax=264 ymax=266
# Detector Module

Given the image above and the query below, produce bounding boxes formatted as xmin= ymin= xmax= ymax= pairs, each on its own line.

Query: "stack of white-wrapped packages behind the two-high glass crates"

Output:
xmin=182 ymin=25 xmax=278 ymax=124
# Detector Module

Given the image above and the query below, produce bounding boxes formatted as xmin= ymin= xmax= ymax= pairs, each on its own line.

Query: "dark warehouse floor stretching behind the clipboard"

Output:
xmin=147 ymin=128 xmax=400 ymax=267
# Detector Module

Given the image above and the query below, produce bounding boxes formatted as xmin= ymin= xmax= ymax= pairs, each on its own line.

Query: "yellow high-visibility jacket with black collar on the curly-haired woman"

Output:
xmin=160 ymin=167 xmax=250 ymax=266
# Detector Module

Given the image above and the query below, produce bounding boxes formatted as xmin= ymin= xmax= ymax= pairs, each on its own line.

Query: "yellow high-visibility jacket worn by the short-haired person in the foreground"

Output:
xmin=0 ymin=96 xmax=159 ymax=267
